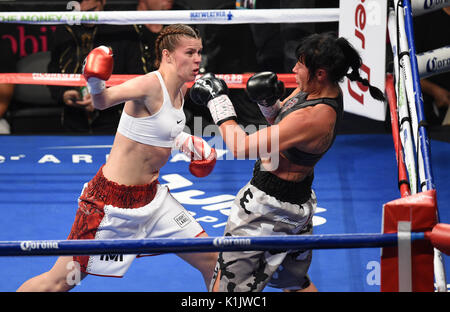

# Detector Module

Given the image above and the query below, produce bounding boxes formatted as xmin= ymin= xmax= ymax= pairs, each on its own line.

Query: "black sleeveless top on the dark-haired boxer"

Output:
xmin=274 ymin=92 xmax=344 ymax=166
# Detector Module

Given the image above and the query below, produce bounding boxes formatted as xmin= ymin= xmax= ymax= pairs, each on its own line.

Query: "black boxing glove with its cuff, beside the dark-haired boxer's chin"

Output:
xmin=246 ymin=72 xmax=285 ymax=123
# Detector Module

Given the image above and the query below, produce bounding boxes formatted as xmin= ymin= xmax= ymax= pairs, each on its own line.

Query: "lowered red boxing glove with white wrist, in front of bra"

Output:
xmin=175 ymin=132 xmax=217 ymax=178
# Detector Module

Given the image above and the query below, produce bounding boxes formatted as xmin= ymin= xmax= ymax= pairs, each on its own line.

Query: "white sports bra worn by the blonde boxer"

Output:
xmin=117 ymin=71 xmax=186 ymax=147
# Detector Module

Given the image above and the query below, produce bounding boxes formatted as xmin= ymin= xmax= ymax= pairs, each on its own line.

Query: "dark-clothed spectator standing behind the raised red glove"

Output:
xmin=48 ymin=0 xmax=132 ymax=134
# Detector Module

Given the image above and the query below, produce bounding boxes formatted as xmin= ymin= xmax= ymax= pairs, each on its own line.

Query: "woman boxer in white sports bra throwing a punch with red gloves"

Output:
xmin=19 ymin=24 xmax=217 ymax=291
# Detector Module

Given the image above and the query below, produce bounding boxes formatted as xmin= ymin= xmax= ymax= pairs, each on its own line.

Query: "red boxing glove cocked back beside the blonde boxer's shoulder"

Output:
xmin=83 ymin=46 xmax=114 ymax=94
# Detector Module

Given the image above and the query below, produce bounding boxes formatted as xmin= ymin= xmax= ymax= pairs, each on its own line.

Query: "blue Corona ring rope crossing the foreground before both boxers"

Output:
xmin=0 ymin=232 xmax=425 ymax=256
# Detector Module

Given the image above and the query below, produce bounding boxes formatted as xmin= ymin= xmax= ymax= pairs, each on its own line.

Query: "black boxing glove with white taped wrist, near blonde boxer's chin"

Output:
xmin=189 ymin=73 xmax=236 ymax=126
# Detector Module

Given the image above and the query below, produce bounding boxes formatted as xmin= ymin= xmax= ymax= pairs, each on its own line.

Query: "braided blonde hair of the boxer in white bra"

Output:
xmin=155 ymin=24 xmax=201 ymax=68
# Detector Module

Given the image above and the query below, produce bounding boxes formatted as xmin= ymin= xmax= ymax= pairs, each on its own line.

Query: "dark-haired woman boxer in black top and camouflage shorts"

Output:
xmin=191 ymin=33 xmax=383 ymax=292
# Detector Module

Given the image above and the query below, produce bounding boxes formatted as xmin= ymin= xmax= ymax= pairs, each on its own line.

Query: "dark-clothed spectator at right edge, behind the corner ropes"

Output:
xmin=414 ymin=7 xmax=450 ymax=127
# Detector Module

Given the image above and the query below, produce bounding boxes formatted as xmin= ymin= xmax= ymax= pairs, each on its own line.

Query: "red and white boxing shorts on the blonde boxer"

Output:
xmin=68 ymin=167 xmax=204 ymax=277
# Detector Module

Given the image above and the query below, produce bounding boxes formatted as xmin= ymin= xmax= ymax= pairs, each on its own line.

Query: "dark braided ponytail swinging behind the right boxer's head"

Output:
xmin=336 ymin=37 xmax=386 ymax=101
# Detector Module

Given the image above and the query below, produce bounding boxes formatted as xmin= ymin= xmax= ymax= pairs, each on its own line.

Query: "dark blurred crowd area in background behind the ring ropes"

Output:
xmin=0 ymin=0 xmax=450 ymax=140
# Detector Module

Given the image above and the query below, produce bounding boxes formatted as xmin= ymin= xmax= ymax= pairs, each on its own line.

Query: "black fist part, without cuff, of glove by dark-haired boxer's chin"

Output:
xmin=246 ymin=72 xmax=284 ymax=106
